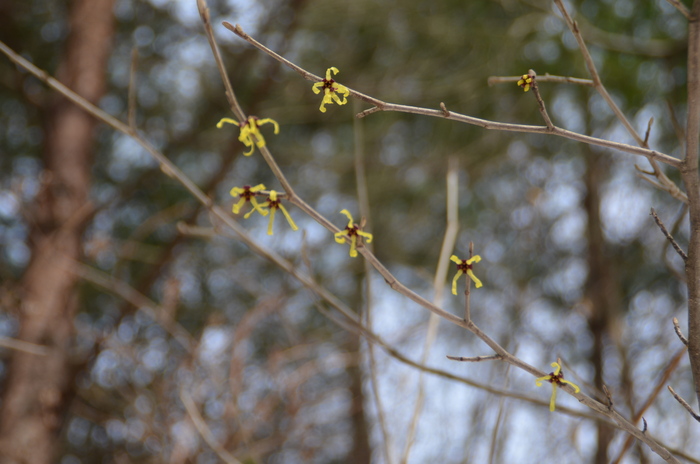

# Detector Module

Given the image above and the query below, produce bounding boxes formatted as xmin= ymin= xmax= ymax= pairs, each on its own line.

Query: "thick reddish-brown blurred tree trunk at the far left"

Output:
xmin=0 ymin=0 xmax=113 ymax=464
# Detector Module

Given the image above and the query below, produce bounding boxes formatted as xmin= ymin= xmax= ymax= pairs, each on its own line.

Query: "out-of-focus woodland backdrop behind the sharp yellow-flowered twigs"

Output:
xmin=0 ymin=0 xmax=700 ymax=464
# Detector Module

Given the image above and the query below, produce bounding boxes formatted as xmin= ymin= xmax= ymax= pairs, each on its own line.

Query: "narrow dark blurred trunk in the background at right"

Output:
xmin=584 ymin=149 xmax=620 ymax=464
